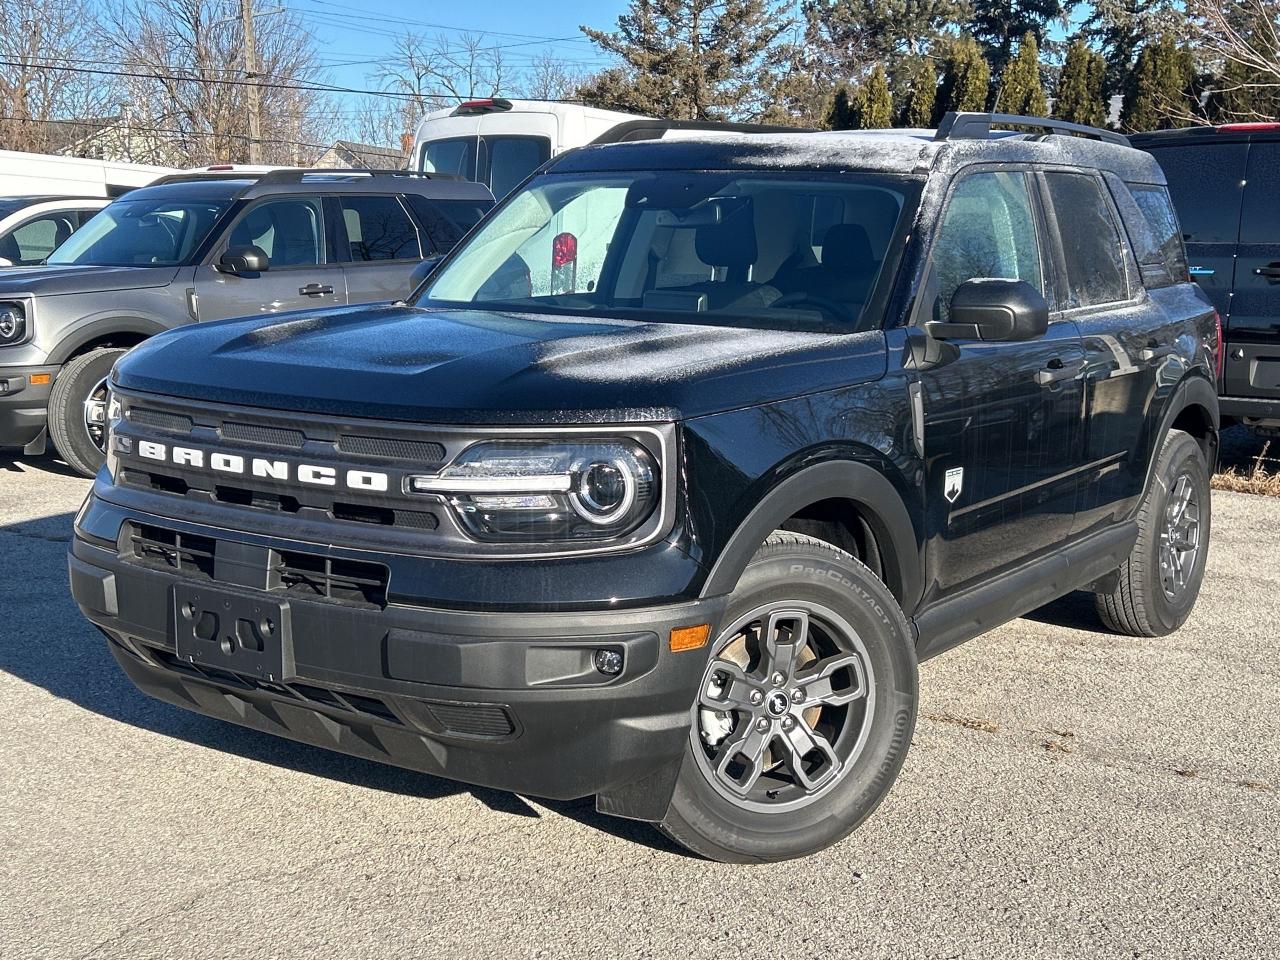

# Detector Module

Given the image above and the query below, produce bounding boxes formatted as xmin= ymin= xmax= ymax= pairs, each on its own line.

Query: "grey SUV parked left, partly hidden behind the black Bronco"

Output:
xmin=0 ymin=170 xmax=493 ymax=476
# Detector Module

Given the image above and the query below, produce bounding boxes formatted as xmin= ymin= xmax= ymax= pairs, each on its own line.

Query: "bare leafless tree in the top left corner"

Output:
xmin=0 ymin=0 xmax=111 ymax=154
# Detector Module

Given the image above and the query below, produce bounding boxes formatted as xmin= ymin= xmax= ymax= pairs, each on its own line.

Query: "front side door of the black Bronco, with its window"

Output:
xmin=920 ymin=170 xmax=1084 ymax=602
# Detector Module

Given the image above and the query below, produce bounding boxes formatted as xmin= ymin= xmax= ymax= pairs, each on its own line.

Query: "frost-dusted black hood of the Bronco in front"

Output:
xmin=115 ymin=305 xmax=886 ymax=424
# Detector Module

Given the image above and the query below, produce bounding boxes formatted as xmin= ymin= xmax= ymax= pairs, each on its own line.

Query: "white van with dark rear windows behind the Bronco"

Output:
xmin=410 ymin=97 xmax=648 ymax=200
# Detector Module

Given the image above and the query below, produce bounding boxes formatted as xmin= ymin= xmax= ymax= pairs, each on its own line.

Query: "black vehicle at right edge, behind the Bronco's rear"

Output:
xmin=1129 ymin=123 xmax=1280 ymax=436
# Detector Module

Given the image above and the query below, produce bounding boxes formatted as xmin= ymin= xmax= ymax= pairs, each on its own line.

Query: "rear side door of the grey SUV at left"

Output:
xmin=326 ymin=193 xmax=424 ymax=303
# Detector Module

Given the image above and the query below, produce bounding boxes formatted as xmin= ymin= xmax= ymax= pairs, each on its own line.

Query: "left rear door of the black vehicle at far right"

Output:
xmin=1149 ymin=141 xmax=1248 ymax=317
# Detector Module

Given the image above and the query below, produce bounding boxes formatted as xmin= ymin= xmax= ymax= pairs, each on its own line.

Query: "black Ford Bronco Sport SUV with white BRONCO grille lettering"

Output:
xmin=70 ymin=115 xmax=1219 ymax=861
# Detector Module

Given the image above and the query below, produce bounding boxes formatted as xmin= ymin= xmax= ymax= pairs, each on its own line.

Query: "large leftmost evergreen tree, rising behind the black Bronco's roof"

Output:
xmin=579 ymin=0 xmax=791 ymax=120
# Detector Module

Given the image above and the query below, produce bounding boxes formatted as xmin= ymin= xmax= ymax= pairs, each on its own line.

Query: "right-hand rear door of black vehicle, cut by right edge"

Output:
xmin=1222 ymin=140 xmax=1280 ymax=399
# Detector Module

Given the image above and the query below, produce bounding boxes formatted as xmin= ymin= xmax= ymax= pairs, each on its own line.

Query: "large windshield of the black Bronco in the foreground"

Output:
xmin=417 ymin=172 xmax=918 ymax=332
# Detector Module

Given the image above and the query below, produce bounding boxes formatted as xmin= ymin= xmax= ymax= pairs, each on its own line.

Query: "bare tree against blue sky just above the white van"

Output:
xmin=376 ymin=33 xmax=513 ymax=115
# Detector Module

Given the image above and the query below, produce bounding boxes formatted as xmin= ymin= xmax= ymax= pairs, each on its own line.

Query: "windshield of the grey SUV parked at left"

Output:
xmin=49 ymin=198 xmax=230 ymax=266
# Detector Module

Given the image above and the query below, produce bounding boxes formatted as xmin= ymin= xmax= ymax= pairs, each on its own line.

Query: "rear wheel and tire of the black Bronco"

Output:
xmin=1094 ymin=430 xmax=1212 ymax=636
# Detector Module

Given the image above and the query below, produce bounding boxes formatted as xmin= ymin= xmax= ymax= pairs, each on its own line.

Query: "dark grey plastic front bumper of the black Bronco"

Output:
xmin=69 ymin=521 xmax=724 ymax=819
